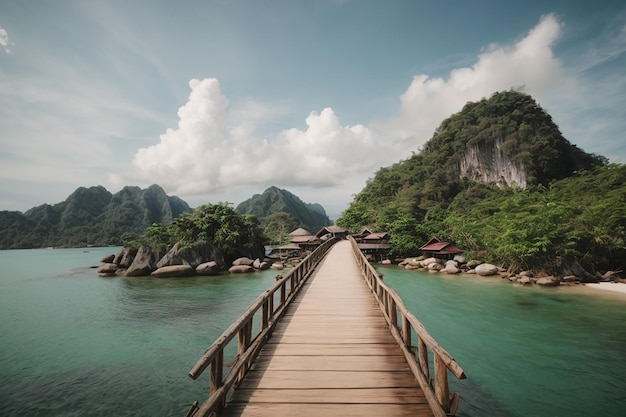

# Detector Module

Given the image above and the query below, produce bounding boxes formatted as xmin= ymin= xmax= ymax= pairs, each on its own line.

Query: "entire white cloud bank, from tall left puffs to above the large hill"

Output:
xmin=113 ymin=15 xmax=573 ymax=202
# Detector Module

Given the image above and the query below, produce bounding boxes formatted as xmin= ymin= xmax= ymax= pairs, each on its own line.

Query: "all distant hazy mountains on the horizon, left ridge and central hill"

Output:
xmin=0 ymin=185 xmax=331 ymax=249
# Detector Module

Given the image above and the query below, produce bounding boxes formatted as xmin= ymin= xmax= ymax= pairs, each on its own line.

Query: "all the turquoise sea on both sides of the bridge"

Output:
xmin=0 ymin=248 xmax=626 ymax=417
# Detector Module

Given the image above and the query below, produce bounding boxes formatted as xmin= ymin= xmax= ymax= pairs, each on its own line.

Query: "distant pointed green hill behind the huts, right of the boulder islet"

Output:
xmin=235 ymin=187 xmax=331 ymax=241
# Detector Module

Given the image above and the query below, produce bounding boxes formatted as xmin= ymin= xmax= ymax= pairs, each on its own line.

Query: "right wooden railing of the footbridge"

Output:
xmin=348 ymin=237 xmax=465 ymax=417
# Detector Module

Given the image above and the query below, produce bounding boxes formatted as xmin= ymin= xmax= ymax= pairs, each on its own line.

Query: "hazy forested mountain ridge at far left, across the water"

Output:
xmin=0 ymin=185 xmax=191 ymax=249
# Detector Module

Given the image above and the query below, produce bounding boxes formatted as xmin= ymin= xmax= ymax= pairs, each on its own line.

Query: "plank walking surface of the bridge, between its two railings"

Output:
xmin=223 ymin=241 xmax=433 ymax=417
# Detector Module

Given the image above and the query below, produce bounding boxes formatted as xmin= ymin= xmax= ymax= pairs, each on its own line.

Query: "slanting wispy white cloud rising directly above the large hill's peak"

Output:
xmin=384 ymin=15 xmax=572 ymax=145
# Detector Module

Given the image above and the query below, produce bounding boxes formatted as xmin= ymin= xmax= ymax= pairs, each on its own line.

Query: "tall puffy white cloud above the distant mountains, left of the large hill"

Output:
xmin=113 ymin=78 xmax=380 ymax=195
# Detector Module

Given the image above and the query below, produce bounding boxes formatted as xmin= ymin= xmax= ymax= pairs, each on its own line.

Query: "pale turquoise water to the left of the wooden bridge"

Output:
xmin=0 ymin=248 xmax=276 ymax=417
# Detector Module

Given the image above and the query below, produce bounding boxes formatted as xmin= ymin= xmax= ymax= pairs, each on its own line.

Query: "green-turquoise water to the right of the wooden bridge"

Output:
xmin=379 ymin=267 xmax=626 ymax=417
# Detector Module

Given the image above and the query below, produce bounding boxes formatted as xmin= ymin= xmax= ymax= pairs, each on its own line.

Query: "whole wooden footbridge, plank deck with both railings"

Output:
xmin=187 ymin=240 xmax=465 ymax=417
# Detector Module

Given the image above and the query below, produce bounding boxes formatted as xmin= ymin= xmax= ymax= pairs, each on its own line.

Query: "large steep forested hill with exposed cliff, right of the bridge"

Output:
xmin=337 ymin=91 xmax=626 ymax=274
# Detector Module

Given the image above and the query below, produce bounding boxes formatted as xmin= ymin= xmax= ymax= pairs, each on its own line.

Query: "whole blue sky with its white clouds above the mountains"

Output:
xmin=0 ymin=0 xmax=626 ymax=219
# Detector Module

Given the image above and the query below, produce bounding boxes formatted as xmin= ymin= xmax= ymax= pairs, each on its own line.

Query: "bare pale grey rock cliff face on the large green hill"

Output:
xmin=459 ymin=139 xmax=527 ymax=189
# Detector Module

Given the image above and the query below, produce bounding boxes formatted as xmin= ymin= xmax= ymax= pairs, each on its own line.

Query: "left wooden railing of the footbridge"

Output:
xmin=187 ymin=238 xmax=339 ymax=417
